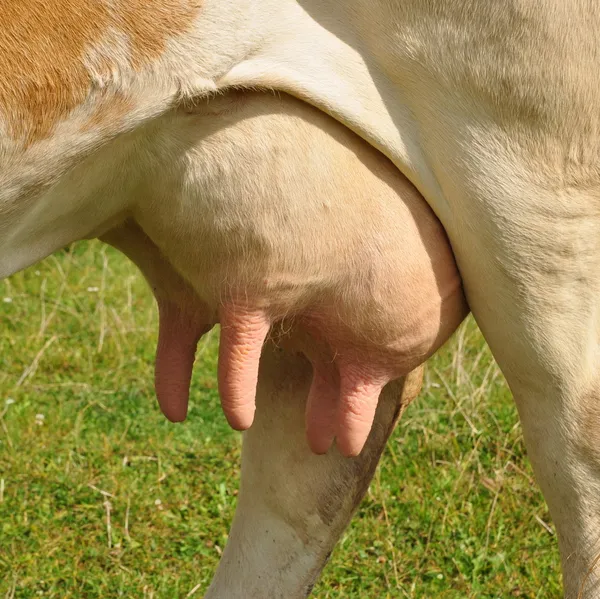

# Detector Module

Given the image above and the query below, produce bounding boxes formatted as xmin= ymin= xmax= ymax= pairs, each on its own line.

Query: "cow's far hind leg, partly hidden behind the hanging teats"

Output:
xmin=206 ymin=343 xmax=422 ymax=599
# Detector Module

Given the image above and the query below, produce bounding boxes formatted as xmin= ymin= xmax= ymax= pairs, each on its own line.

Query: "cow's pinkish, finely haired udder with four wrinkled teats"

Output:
xmin=103 ymin=93 xmax=467 ymax=456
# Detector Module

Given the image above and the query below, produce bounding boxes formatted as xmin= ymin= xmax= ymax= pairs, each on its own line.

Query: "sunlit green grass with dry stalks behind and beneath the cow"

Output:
xmin=0 ymin=242 xmax=560 ymax=599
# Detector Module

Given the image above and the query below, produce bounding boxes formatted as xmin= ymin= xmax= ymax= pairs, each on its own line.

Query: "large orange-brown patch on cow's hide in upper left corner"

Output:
xmin=0 ymin=0 xmax=200 ymax=144
